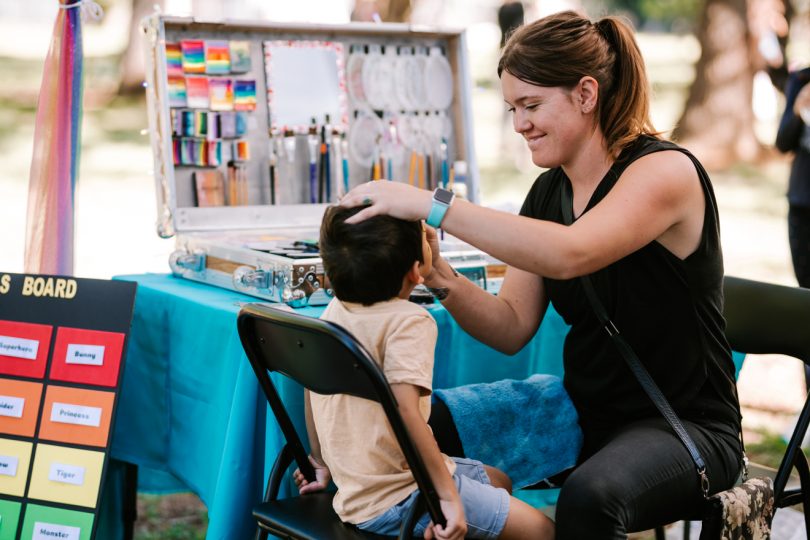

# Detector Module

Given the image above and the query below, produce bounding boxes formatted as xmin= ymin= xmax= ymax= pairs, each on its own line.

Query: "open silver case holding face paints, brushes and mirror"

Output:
xmin=142 ymin=15 xmax=486 ymax=306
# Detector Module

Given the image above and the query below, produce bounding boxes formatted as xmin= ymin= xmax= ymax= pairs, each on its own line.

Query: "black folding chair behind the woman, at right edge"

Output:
xmin=656 ymin=276 xmax=810 ymax=540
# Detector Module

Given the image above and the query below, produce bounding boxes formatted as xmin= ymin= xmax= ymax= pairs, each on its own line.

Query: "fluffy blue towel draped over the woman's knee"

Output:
xmin=434 ymin=375 xmax=582 ymax=489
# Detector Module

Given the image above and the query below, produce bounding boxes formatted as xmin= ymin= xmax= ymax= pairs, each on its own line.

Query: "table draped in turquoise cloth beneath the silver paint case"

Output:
xmin=99 ymin=274 xmax=567 ymax=540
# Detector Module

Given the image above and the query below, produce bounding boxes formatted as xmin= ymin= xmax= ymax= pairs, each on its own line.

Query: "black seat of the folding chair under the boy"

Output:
xmin=253 ymin=492 xmax=391 ymax=540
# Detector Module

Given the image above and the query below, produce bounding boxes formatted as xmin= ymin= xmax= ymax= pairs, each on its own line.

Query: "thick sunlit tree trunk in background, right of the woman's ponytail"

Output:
xmin=672 ymin=0 xmax=762 ymax=169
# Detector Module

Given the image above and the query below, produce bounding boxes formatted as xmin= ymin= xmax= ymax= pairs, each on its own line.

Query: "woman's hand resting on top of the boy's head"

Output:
xmin=338 ymin=180 xmax=432 ymax=223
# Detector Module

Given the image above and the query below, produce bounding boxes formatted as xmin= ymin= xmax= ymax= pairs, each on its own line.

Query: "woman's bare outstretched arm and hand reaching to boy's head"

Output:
xmin=342 ymin=151 xmax=705 ymax=279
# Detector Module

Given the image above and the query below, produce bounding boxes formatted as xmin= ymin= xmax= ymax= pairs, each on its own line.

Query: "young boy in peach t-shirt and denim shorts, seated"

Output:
xmin=294 ymin=206 xmax=553 ymax=539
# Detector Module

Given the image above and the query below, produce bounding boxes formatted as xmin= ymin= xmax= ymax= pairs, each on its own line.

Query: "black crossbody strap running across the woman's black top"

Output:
xmin=560 ymin=182 xmax=709 ymax=497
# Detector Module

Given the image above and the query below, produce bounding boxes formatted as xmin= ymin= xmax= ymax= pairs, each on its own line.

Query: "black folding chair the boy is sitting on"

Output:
xmin=237 ymin=304 xmax=445 ymax=540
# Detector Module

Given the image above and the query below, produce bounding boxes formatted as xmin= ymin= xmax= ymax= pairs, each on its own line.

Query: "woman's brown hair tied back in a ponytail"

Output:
xmin=498 ymin=11 xmax=658 ymax=155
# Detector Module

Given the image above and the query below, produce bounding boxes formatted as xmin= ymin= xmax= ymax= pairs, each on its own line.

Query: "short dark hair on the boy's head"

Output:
xmin=319 ymin=206 xmax=424 ymax=306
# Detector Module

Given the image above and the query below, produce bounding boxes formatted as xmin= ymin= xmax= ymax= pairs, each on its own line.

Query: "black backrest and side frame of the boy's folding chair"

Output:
xmin=237 ymin=304 xmax=445 ymax=525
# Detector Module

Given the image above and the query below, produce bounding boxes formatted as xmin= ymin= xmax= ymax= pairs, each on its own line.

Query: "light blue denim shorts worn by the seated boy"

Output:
xmin=357 ymin=458 xmax=509 ymax=539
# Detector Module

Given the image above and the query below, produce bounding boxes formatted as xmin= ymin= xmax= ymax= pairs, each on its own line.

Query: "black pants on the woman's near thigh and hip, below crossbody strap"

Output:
xmin=555 ymin=418 xmax=741 ymax=540
